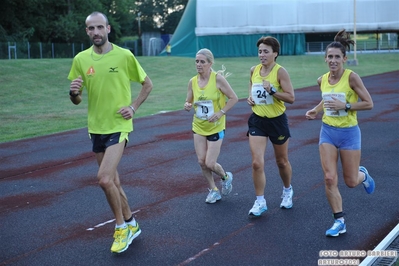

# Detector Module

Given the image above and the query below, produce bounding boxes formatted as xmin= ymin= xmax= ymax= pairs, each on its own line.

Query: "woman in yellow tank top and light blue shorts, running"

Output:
xmin=306 ymin=30 xmax=375 ymax=237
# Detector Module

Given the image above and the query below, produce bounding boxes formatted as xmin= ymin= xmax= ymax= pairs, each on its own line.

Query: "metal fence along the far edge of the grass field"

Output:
xmin=0 ymin=40 xmax=399 ymax=59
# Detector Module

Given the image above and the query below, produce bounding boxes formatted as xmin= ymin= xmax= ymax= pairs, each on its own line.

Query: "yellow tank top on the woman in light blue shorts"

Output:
xmin=320 ymin=69 xmax=359 ymax=128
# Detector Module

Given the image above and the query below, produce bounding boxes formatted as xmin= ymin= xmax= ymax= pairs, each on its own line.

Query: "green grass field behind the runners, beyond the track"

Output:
xmin=0 ymin=53 xmax=399 ymax=143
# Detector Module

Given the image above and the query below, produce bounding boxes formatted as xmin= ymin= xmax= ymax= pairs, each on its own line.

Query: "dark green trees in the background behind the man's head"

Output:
xmin=0 ymin=0 xmax=188 ymax=43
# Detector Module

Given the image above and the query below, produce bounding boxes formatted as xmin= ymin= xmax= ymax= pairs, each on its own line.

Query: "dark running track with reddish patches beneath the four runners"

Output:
xmin=0 ymin=71 xmax=399 ymax=265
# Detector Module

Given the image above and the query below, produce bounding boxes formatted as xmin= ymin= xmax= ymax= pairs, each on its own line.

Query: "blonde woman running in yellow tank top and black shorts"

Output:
xmin=184 ymin=49 xmax=238 ymax=203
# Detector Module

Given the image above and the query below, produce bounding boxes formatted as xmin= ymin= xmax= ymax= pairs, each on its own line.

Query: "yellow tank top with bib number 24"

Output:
xmin=251 ymin=64 xmax=286 ymax=118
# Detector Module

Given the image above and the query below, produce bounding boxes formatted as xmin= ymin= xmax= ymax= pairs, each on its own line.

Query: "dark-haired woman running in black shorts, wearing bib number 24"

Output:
xmin=247 ymin=36 xmax=295 ymax=216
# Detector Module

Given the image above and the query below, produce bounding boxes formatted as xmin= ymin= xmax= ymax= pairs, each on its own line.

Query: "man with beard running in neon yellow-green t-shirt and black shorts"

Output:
xmin=68 ymin=12 xmax=152 ymax=253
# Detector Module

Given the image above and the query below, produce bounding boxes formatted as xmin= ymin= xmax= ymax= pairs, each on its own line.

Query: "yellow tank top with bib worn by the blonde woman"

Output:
xmin=192 ymin=72 xmax=226 ymax=136
